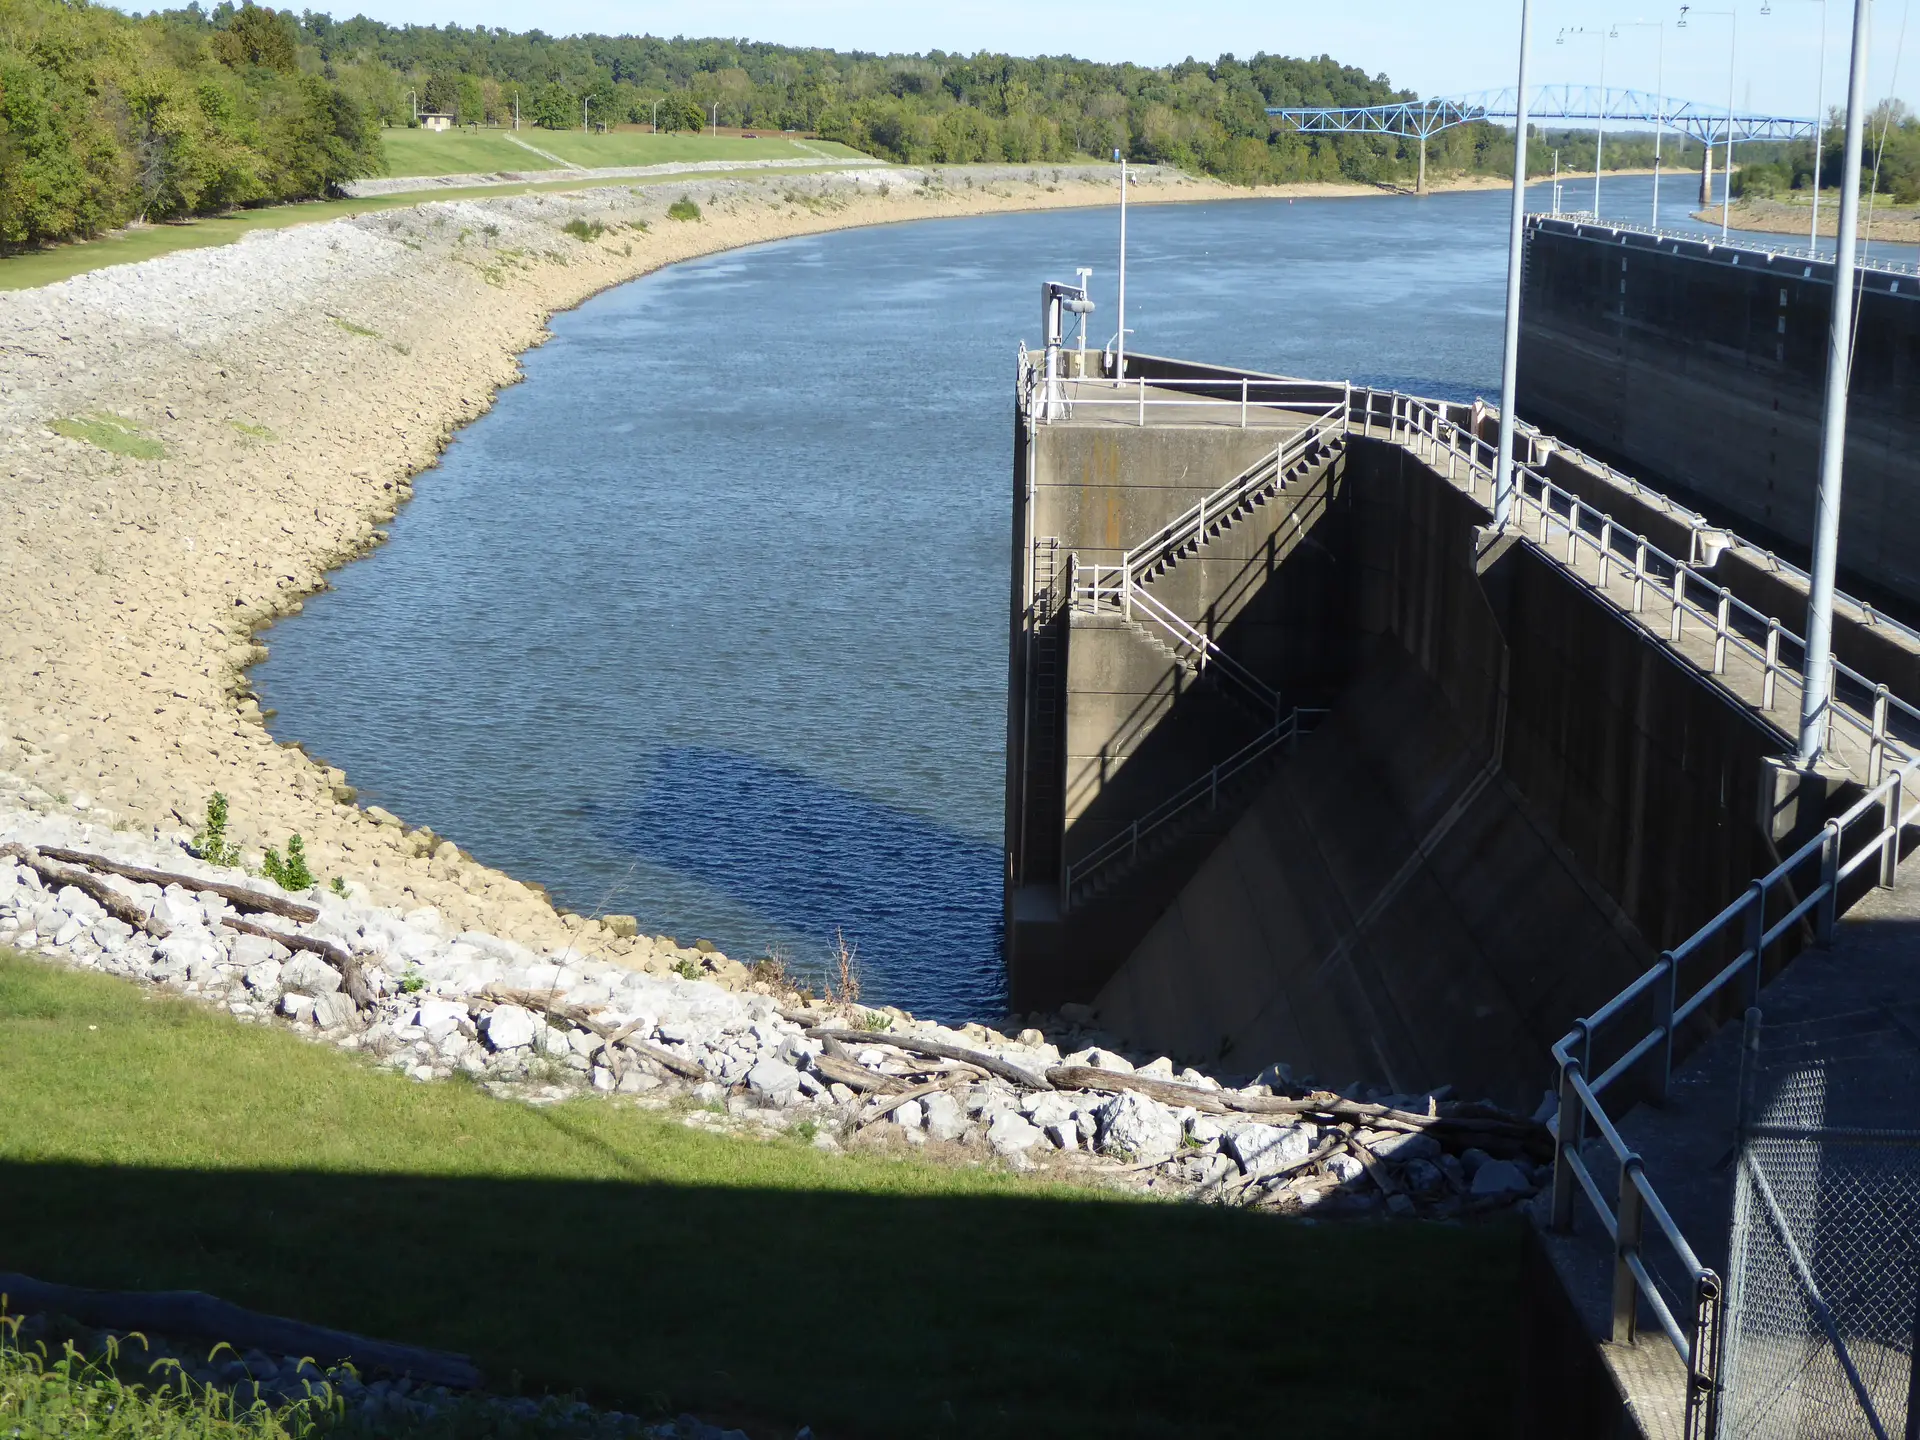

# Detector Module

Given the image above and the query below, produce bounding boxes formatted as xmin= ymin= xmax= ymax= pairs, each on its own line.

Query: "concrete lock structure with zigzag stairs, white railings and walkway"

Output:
xmin=1006 ymin=318 xmax=1920 ymax=1436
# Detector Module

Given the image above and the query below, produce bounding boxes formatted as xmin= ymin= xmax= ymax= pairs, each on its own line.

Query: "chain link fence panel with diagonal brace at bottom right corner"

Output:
xmin=1718 ymin=1066 xmax=1920 ymax=1440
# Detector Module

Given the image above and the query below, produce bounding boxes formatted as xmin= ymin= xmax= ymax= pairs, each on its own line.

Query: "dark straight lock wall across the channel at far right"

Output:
xmin=1519 ymin=217 xmax=1920 ymax=609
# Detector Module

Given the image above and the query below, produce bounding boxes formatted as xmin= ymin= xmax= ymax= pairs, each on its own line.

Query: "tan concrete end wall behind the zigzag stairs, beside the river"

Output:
xmin=1006 ymin=401 xmax=1338 ymax=1006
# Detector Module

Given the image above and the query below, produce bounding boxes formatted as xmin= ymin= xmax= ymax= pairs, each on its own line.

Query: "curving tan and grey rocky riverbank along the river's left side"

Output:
xmin=0 ymin=167 xmax=1305 ymax=963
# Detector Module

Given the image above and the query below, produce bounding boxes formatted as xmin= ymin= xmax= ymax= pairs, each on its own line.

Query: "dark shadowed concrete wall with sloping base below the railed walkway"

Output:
xmin=1094 ymin=442 xmax=1776 ymax=1108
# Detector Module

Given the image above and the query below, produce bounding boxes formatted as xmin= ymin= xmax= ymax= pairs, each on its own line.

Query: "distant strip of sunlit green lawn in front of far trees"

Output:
xmin=382 ymin=127 xmax=860 ymax=177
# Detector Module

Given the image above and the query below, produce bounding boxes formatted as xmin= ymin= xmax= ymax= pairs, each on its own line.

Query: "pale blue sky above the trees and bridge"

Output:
xmin=322 ymin=0 xmax=1920 ymax=115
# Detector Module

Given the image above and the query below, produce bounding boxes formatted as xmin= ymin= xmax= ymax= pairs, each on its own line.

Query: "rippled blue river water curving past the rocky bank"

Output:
xmin=255 ymin=177 xmax=1904 ymax=1020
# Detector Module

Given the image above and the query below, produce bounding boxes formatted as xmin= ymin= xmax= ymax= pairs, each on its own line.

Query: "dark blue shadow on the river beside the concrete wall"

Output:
xmin=591 ymin=747 xmax=1004 ymax=1020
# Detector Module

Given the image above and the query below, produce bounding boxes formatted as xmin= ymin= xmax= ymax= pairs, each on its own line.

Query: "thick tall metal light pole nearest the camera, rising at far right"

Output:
xmin=1799 ymin=0 xmax=1872 ymax=764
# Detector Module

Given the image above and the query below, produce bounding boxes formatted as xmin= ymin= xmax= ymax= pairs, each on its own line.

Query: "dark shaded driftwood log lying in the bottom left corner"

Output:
xmin=0 ymin=1273 xmax=482 ymax=1390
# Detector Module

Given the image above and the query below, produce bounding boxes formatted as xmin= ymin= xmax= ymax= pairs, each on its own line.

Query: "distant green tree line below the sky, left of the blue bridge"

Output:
xmin=280 ymin=12 xmax=1543 ymax=182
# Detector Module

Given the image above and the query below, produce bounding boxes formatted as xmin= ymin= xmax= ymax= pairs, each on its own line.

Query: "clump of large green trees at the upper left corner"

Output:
xmin=0 ymin=0 xmax=382 ymax=246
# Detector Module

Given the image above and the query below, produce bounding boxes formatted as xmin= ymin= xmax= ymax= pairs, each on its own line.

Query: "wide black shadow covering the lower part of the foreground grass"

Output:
xmin=0 ymin=1159 xmax=1521 ymax=1436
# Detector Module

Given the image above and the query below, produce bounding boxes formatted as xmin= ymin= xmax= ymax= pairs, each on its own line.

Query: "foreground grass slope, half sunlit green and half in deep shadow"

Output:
xmin=0 ymin=952 xmax=1521 ymax=1436
